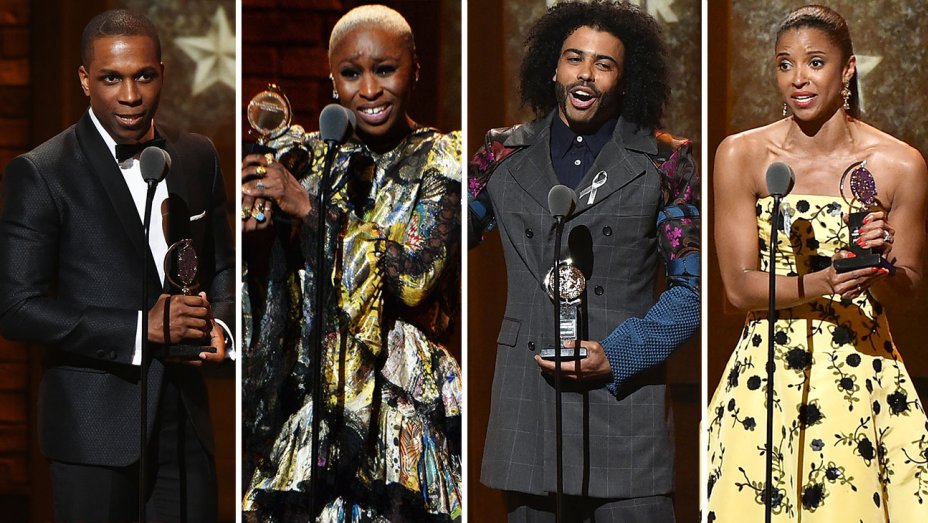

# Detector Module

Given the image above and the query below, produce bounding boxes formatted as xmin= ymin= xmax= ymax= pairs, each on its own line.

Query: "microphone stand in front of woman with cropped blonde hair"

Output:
xmin=309 ymin=140 xmax=339 ymax=518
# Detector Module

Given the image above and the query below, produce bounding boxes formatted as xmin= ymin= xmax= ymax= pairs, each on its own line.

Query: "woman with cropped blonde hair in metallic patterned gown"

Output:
xmin=242 ymin=6 xmax=461 ymax=522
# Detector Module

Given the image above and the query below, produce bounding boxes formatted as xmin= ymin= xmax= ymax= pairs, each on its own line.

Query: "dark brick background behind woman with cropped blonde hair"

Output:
xmin=239 ymin=0 xmax=464 ymax=508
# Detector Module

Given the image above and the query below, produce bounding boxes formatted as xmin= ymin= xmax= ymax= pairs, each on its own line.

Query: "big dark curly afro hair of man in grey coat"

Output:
xmin=520 ymin=0 xmax=670 ymax=129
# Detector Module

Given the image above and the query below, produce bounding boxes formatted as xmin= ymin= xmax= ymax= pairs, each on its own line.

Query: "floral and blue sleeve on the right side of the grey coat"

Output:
xmin=602 ymin=135 xmax=700 ymax=394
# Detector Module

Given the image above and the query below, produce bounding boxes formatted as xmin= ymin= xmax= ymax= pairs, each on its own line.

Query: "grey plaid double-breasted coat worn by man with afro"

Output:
xmin=471 ymin=111 xmax=673 ymax=498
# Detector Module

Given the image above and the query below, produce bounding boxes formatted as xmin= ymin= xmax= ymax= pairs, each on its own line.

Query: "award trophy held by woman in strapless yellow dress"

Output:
xmin=833 ymin=160 xmax=895 ymax=274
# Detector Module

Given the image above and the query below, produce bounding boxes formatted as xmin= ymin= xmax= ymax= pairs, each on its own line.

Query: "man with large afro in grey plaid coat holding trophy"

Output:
xmin=468 ymin=0 xmax=699 ymax=522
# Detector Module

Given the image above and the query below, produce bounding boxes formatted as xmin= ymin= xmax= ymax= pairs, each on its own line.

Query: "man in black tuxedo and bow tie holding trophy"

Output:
xmin=0 ymin=10 xmax=235 ymax=522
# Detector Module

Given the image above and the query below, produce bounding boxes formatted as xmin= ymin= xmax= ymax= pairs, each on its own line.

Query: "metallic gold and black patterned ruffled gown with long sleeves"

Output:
xmin=243 ymin=128 xmax=461 ymax=522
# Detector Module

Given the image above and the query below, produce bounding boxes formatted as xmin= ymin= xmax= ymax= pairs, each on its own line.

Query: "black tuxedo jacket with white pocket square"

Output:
xmin=0 ymin=109 xmax=235 ymax=466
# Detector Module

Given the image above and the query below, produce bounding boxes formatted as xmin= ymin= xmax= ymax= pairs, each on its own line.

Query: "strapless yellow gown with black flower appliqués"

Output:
xmin=704 ymin=194 xmax=928 ymax=523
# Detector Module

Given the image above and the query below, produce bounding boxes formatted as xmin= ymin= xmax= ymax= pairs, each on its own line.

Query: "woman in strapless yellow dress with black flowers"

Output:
xmin=703 ymin=6 xmax=928 ymax=523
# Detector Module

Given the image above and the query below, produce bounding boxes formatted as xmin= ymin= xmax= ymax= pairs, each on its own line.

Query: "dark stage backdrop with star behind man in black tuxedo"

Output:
xmin=0 ymin=0 xmax=238 ymax=522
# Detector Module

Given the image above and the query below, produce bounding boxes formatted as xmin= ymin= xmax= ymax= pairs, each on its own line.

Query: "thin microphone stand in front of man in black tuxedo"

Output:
xmin=139 ymin=179 xmax=159 ymax=523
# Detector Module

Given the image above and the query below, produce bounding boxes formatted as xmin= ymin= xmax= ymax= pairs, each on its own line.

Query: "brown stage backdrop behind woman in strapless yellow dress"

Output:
xmin=707 ymin=0 xmax=928 ymax=426
